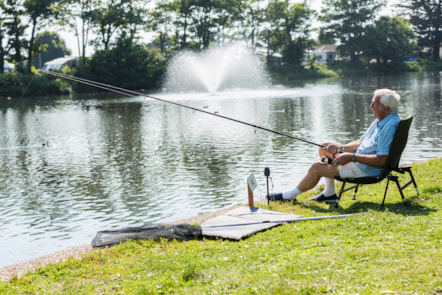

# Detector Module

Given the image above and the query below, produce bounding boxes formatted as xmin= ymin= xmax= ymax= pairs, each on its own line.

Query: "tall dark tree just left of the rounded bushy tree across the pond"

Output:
xmin=320 ymin=0 xmax=385 ymax=63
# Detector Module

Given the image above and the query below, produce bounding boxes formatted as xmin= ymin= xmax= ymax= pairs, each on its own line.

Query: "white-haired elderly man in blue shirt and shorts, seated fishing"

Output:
xmin=267 ymin=89 xmax=401 ymax=202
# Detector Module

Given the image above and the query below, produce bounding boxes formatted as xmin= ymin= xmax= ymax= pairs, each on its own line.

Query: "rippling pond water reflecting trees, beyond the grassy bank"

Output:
xmin=0 ymin=73 xmax=442 ymax=265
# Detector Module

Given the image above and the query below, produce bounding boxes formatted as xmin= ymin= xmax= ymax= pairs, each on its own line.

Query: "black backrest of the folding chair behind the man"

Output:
xmin=384 ymin=116 xmax=413 ymax=174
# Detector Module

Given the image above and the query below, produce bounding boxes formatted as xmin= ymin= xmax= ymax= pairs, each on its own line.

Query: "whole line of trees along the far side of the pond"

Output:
xmin=0 ymin=0 xmax=442 ymax=93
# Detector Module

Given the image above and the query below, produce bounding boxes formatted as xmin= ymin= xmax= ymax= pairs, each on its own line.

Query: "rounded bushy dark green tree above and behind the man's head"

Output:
xmin=363 ymin=16 xmax=416 ymax=65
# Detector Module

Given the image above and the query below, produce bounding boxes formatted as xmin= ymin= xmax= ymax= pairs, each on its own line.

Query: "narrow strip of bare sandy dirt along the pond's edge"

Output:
xmin=0 ymin=201 xmax=245 ymax=282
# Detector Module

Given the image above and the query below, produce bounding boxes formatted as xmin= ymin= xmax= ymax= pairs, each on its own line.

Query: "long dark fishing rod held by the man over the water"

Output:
xmin=40 ymin=71 xmax=325 ymax=148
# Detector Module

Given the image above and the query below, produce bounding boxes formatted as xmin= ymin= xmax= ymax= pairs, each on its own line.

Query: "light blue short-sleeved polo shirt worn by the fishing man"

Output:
xmin=355 ymin=113 xmax=401 ymax=176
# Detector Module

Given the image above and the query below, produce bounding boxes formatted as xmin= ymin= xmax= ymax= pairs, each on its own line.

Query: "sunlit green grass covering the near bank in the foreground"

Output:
xmin=0 ymin=159 xmax=442 ymax=294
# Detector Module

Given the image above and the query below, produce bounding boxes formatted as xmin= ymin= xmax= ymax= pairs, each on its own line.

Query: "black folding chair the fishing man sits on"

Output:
xmin=335 ymin=116 xmax=419 ymax=209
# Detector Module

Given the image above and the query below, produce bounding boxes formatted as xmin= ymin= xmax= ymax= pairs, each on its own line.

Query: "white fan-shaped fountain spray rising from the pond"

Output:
xmin=164 ymin=43 xmax=269 ymax=94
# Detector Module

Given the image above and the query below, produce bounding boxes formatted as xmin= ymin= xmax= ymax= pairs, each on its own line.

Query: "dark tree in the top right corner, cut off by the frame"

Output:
xmin=399 ymin=0 xmax=442 ymax=61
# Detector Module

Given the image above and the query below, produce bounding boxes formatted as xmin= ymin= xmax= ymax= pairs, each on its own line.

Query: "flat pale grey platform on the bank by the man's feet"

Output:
xmin=201 ymin=206 xmax=302 ymax=240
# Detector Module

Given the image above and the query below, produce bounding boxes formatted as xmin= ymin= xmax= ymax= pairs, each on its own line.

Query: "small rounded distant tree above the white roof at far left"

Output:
xmin=33 ymin=31 xmax=71 ymax=68
